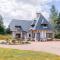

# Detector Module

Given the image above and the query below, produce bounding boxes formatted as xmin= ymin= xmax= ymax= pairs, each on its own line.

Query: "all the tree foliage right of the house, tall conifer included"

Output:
xmin=50 ymin=5 xmax=60 ymax=38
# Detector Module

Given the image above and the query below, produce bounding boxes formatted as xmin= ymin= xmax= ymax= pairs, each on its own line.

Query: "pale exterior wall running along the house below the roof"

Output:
xmin=12 ymin=30 xmax=53 ymax=41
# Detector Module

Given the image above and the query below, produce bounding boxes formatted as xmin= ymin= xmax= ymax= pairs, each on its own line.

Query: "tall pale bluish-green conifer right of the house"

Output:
xmin=50 ymin=5 xmax=58 ymax=30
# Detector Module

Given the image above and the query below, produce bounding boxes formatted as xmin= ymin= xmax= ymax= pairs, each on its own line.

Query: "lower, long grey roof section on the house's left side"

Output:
xmin=10 ymin=19 xmax=32 ymax=31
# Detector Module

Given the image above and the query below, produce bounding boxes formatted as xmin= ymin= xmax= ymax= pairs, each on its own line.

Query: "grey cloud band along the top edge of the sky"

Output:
xmin=16 ymin=0 xmax=52 ymax=5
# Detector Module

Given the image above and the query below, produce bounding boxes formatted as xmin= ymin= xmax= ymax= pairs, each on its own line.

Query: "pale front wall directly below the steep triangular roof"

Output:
xmin=33 ymin=30 xmax=53 ymax=41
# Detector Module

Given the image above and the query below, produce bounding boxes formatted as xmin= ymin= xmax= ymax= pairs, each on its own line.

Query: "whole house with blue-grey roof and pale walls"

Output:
xmin=10 ymin=13 xmax=54 ymax=41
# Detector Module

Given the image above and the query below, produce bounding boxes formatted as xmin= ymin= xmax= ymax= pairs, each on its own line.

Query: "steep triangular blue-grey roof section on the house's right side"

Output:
xmin=32 ymin=14 xmax=52 ymax=30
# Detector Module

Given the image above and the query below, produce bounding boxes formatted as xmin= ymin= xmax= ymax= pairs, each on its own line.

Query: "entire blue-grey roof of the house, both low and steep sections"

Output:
xmin=10 ymin=13 xmax=52 ymax=32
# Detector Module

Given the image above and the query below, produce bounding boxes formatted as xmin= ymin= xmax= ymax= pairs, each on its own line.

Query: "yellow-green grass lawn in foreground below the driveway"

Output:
xmin=0 ymin=48 xmax=60 ymax=60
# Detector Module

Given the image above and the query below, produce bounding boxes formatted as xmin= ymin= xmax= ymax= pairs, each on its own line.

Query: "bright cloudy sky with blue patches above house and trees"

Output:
xmin=0 ymin=0 xmax=60 ymax=27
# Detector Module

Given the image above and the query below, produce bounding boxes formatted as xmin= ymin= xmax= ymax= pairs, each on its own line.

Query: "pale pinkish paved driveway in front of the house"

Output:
xmin=0 ymin=41 xmax=60 ymax=56
